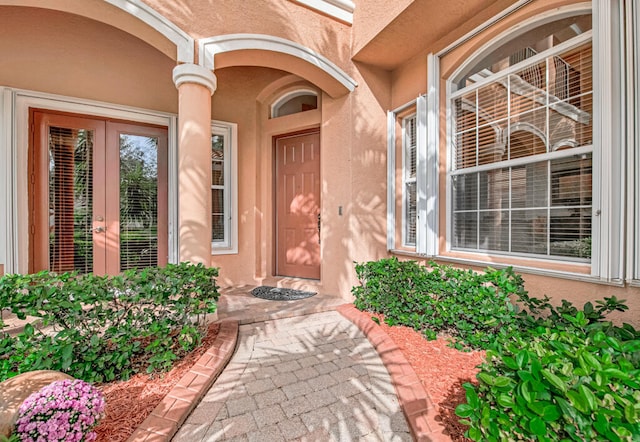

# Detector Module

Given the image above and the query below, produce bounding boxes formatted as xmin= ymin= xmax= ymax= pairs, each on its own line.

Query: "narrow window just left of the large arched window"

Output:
xmin=402 ymin=115 xmax=418 ymax=246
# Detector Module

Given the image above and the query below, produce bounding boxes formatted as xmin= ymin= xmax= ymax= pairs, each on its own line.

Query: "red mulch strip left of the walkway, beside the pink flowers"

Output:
xmin=95 ymin=324 xmax=220 ymax=442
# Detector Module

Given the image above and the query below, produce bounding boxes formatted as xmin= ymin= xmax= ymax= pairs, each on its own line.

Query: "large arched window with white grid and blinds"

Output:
xmin=448 ymin=14 xmax=594 ymax=262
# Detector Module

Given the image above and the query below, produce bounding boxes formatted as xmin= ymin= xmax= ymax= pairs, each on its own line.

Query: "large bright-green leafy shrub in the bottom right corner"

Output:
xmin=456 ymin=322 xmax=640 ymax=441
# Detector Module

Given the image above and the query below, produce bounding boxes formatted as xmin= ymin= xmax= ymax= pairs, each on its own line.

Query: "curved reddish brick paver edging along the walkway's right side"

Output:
xmin=337 ymin=304 xmax=451 ymax=442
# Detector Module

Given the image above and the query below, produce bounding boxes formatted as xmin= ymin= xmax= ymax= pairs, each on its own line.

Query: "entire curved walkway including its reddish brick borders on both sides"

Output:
xmin=128 ymin=287 xmax=451 ymax=442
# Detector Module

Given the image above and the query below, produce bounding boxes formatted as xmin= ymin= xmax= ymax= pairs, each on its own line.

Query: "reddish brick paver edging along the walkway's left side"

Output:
xmin=127 ymin=321 xmax=238 ymax=442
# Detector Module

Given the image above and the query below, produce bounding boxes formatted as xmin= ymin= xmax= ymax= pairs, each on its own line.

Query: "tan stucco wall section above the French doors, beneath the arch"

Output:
xmin=0 ymin=6 xmax=178 ymax=112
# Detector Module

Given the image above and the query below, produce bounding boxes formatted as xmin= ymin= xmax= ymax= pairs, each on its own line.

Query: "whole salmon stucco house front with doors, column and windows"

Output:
xmin=0 ymin=0 xmax=640 ymax=326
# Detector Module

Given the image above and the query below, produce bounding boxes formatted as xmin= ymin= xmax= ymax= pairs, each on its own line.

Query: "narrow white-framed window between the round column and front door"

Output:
xmin=211 ymin=123 xmax=237 ymax=254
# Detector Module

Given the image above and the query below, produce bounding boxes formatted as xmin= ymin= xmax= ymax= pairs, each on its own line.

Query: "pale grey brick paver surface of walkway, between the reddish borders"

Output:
xmin=173 ymin=312 xmax=412 ymax=442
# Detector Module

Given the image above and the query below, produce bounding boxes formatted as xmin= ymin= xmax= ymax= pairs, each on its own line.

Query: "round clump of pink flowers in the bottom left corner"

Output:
xmin=16 ymin=379 xmax=105 ymax=442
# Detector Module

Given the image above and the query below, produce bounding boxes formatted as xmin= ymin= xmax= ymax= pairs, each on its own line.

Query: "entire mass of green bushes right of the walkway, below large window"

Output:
xmin=352 ymin=258 xmax=640 ymax=441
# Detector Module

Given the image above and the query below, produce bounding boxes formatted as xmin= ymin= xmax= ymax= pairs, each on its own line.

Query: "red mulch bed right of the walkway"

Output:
xmin=372 ymin=314 xmax=485 ymax=442
